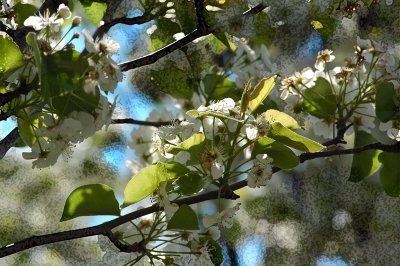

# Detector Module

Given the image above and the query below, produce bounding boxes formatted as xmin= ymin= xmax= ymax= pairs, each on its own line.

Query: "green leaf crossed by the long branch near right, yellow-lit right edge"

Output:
xmin=349 ymin=130 xmax=381 ymax=182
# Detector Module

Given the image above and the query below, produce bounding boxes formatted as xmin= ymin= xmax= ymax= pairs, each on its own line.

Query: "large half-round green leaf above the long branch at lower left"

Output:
xmin=60 ymin=184 xmax=120 ymax=222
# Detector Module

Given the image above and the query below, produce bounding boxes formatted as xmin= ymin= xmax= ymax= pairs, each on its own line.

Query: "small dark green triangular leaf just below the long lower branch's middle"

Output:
xmin=167 ymin=204 xmax=200 ymax=230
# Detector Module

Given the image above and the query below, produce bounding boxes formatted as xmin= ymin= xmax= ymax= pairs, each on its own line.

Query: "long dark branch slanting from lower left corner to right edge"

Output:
xmin=0 ymin=139 xmax=400 ymax=258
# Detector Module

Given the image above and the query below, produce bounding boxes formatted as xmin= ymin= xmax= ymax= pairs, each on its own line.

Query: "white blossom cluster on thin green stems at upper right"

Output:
xmin=281 ymin=38 xmax=400 ymax=140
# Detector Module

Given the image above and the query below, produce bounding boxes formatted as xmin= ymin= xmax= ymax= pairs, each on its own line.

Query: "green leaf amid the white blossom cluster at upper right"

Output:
xmin=303 ymin=77 xmax=337 ymax=118
